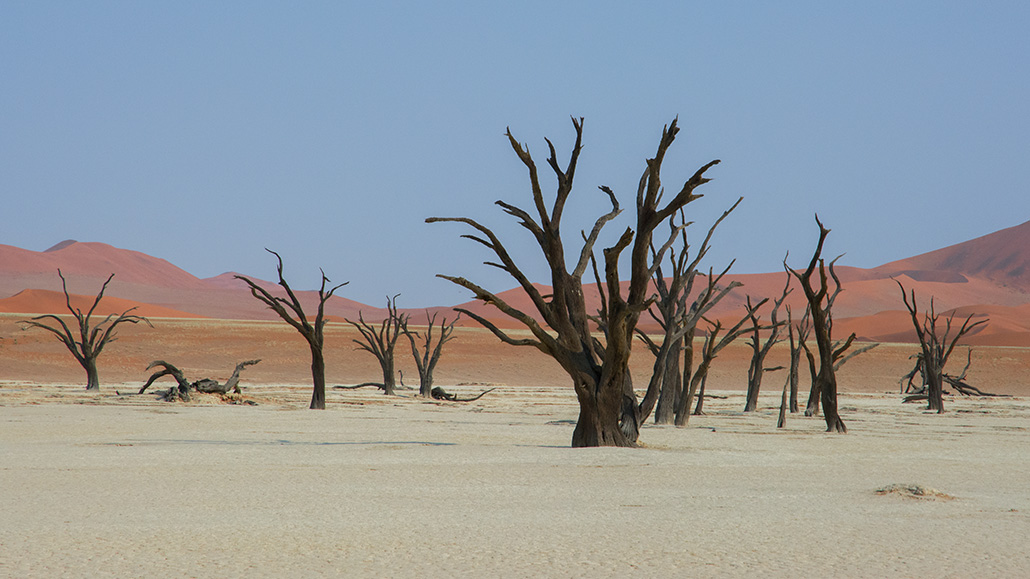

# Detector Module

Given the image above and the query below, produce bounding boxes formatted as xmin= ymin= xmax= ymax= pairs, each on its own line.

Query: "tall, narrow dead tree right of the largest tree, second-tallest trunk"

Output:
xmin=784 ymin=215 xmax=855 ymax=433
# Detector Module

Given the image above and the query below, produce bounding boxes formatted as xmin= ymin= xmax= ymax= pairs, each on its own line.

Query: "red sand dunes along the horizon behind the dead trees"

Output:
xmin=0 ymin=223 xmax=1030 ymax=346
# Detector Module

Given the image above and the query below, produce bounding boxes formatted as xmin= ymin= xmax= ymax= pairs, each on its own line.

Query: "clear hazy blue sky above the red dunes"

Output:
xmin=0 ymin=0 xmax=1030 ymax=307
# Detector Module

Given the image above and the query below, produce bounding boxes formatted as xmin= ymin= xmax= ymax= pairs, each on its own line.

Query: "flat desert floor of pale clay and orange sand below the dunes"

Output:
xmin=0 ymin=314 xmax=1030 ymax=577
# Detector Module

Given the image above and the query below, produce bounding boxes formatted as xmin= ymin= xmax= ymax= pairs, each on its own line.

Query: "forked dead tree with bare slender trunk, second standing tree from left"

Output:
xmin=235 ymin=247 xmax=347 ymax=410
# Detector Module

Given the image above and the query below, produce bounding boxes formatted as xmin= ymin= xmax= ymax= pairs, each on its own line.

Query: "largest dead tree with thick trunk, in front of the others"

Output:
xmin=426 ymin=118 xmax=718 ymax=446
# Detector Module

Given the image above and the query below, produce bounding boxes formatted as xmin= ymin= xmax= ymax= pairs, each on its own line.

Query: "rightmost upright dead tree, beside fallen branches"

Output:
xmin=894 ymin=279 xmax=988 ymax=413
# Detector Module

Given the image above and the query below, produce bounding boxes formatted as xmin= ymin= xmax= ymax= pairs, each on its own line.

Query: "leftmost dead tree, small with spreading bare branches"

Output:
xmin=21 ymin=269 xmax=153 ymax=390
